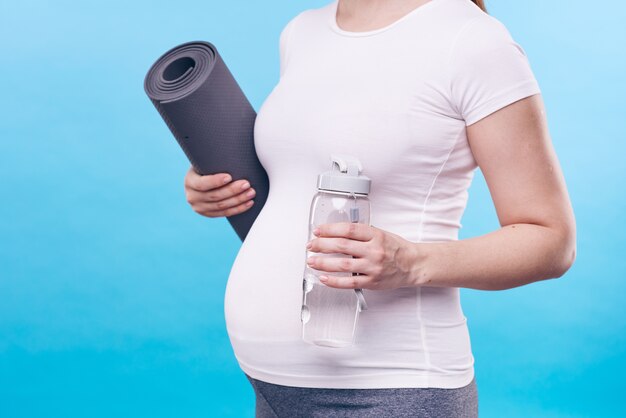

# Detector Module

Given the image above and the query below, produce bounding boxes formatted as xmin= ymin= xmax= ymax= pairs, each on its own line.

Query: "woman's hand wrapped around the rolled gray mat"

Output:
xmin=185 ymin=167 xmax=255 ymax=218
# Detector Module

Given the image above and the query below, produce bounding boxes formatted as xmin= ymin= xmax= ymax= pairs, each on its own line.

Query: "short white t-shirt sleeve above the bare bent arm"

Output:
xmin=449 ymin=14 xmax=541 ymax=126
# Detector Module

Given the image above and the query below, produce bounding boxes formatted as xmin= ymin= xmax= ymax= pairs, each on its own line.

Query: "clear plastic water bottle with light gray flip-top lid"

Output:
xmin=301 ymin=154 xmax=371 ymax=347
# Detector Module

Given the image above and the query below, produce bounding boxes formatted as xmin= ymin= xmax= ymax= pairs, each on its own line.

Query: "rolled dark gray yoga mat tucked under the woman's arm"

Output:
xmin=144 ymin=41 xmax=269 ymax=241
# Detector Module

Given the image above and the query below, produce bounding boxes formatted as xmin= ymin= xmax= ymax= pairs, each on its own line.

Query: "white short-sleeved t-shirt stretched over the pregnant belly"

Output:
xmin=225 ymin=0 xmax=540 ymax=388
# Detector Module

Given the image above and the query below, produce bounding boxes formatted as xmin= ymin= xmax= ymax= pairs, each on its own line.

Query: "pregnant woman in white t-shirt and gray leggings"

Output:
xmin=185 ymin=0 xmax=576 ymax=417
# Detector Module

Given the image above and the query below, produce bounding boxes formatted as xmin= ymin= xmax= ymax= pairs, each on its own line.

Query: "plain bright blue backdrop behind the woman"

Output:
xmin=0 ymin=0 xmax=626 ymax=417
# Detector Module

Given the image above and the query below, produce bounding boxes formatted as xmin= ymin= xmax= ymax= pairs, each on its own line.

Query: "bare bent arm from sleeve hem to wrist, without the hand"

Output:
xmin=406 ymin=94 xmax=576 ymax=290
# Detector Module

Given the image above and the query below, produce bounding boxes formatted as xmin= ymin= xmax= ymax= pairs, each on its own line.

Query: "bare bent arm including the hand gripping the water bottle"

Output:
xmin=307 ymin=94 xmax=576 ymax=290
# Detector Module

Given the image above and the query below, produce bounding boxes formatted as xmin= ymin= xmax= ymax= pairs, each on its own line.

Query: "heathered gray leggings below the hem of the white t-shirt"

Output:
xmin=244 ymin=373 xmax=478 ymax=418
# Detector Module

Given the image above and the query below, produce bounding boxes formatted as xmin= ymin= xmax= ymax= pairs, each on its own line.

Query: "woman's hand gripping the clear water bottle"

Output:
xmin=307 ymin=222 xmax=420 ymax=290
